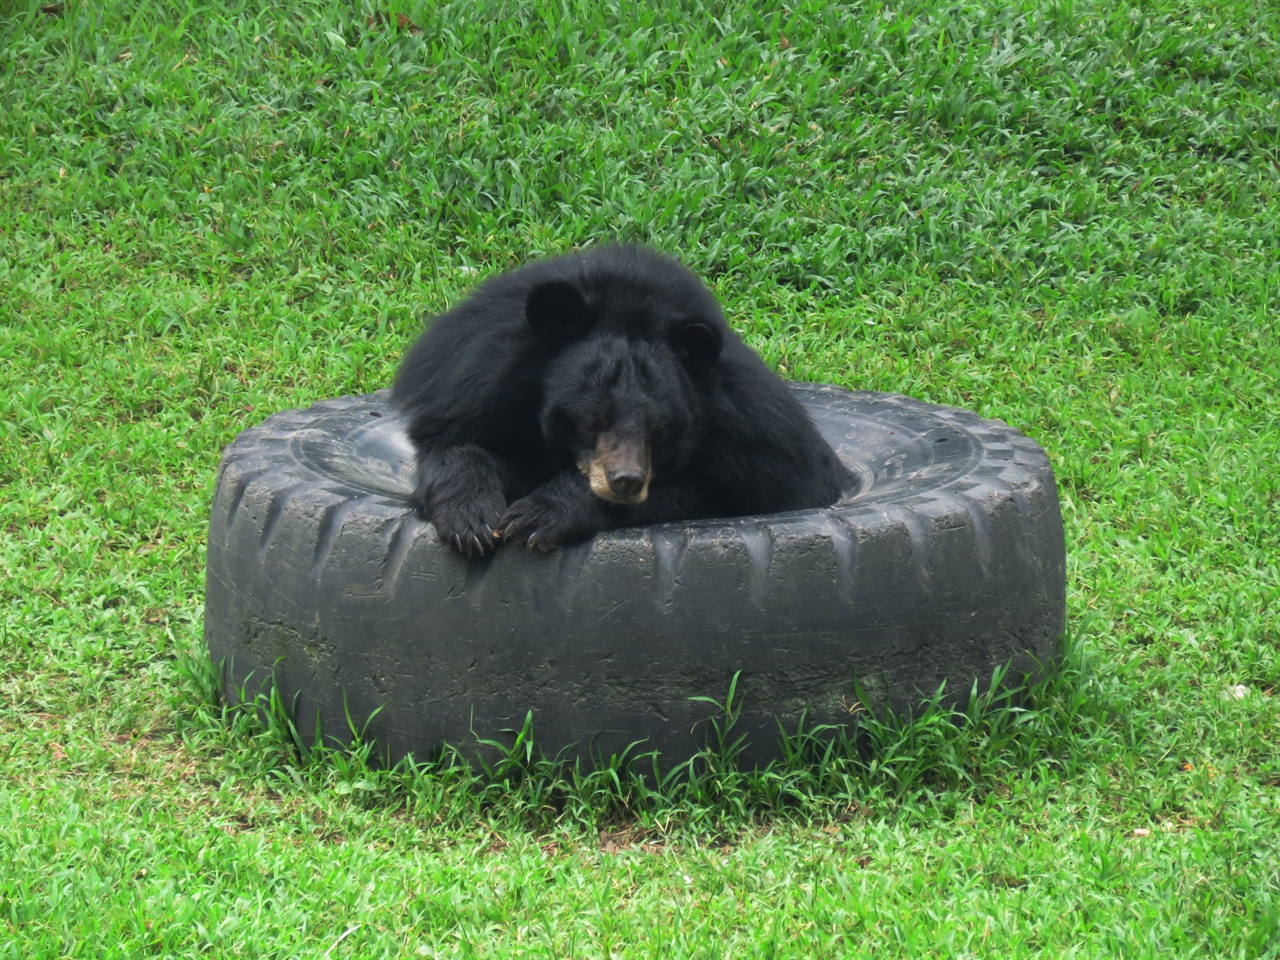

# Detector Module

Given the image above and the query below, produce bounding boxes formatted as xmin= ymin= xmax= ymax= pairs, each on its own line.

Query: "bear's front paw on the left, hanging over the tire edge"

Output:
xmin=410 ymin=444 xmax=508 ymax=557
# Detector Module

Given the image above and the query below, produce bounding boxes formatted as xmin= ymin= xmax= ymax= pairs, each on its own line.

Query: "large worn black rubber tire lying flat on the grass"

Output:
xmin=205 ymin=384 xmax=1065 ymax=763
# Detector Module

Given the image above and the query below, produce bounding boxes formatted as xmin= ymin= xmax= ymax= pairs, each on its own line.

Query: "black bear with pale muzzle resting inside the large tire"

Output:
xmin=392 ymin=246 xmax=846 ymax=554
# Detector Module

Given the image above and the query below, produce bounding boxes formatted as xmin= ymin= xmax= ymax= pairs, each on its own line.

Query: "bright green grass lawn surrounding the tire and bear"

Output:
xmin=0 ymin=0 xmax=1280 ymax=960
